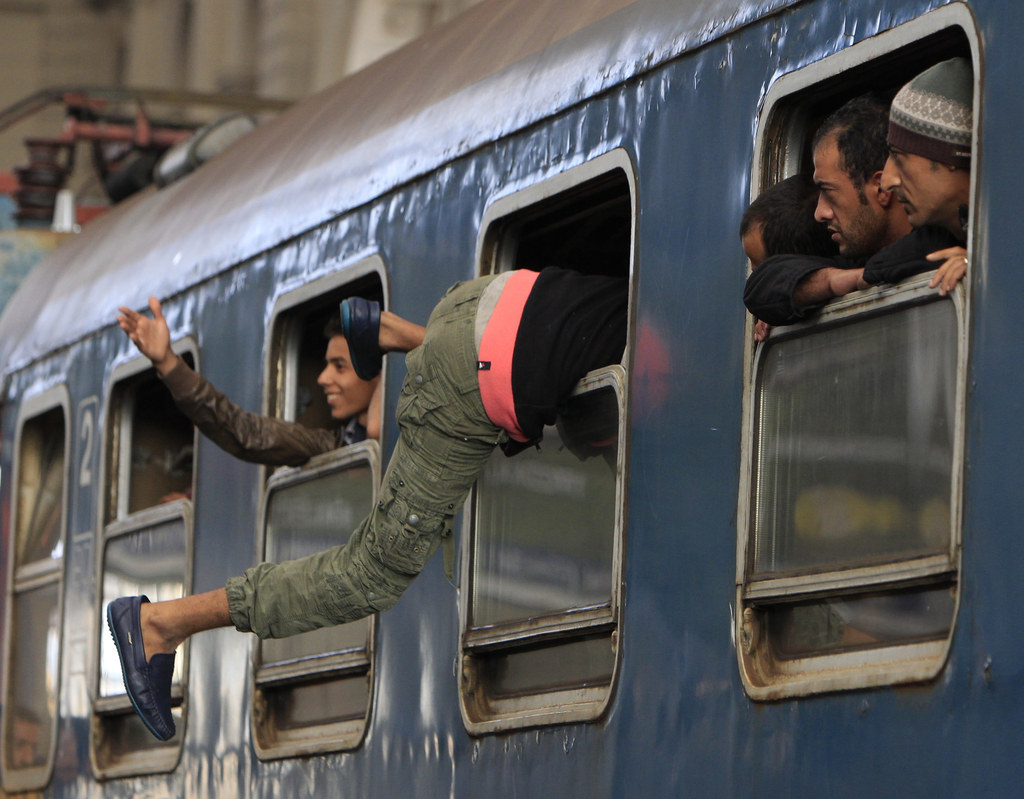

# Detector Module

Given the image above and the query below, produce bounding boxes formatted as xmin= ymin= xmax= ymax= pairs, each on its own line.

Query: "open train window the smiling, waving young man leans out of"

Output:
xmin=253 ymin=256 xmax=384 ymax=758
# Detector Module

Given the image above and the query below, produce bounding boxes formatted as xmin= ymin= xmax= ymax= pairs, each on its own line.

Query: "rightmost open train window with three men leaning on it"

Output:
xmin=735 ymin=6 xmax=978 ymax=700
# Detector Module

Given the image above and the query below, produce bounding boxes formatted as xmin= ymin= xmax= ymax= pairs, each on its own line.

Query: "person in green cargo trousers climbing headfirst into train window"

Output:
xmin=106 ymin=266 xmax=629 ymax=741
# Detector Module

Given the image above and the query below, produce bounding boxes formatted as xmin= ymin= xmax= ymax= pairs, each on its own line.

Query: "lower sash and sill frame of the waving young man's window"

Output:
xmin=250 ymin=439 xmax=382 ymax=760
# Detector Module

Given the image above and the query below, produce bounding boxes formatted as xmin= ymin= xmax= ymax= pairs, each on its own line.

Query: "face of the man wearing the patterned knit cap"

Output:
xmin=882 ymin=148 xmax=971 ymax=235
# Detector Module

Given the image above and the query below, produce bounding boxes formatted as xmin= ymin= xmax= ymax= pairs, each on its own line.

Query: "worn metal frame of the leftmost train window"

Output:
xmin=0 ymin=383 xmax=74 ymax=792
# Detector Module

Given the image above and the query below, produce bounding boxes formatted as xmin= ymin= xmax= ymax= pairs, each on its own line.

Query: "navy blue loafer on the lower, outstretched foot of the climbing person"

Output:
xmin=106 ymin=596 xmax=174 ymax=741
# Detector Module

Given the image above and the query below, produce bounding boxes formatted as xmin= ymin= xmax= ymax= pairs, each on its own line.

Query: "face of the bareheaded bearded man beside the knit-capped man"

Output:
xmin=814 ymin=136 xmax=888 ymax=258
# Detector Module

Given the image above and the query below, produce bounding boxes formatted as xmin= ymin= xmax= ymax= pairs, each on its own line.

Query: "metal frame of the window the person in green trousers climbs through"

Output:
xmin=458 ymin=148 xmax=638 ymax=734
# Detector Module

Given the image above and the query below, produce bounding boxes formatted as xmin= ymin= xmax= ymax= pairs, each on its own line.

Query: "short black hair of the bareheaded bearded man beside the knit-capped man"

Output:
xmin=811 ymin=93 xmax=889 ymax=191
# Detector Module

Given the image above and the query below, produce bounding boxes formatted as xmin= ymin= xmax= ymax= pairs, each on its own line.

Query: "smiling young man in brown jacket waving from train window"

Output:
xmin=118 ymin=297 xmax=395 ymax=466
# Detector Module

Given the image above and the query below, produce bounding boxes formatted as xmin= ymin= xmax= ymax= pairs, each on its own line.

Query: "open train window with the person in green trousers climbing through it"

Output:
xmin=460 ymin=152 xmax=635 ymax=732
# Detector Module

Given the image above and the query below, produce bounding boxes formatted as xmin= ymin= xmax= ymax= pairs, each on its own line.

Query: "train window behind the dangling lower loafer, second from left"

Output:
xmin=91 ymin=342 xmax=196 ymax=777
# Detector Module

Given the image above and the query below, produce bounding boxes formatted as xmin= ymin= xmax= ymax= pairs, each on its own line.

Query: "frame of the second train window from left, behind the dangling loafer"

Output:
xmin=89 ymin=337 xmax=200 ymax=780
